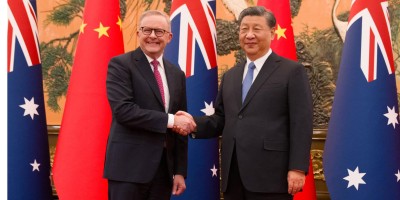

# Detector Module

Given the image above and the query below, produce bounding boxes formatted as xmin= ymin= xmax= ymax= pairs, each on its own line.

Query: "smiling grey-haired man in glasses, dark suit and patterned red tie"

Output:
xmin=104 ymin=10 xmax=193 ymax=200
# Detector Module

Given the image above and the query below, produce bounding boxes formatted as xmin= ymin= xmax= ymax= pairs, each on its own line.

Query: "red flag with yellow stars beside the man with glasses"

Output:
xmin=53 ymin=0 xmax=124 ymax=200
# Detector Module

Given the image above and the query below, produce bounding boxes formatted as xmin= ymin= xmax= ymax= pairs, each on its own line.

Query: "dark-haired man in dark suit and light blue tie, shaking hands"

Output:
xmin=175 ymin=6 xmax=313 ymax=200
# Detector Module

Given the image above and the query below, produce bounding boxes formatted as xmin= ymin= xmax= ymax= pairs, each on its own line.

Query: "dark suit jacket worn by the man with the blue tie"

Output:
xmin=195 ymin=52 xmax=313 ymax=193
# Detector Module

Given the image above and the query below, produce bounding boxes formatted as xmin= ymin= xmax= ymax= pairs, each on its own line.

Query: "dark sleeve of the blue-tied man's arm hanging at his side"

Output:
xmin=288 ymin=64 xmax=313 ymax=173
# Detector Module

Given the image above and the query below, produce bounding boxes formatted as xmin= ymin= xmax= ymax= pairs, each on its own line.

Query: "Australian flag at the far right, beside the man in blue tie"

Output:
xmin=323 ymin=0 xmax=400 ymax=200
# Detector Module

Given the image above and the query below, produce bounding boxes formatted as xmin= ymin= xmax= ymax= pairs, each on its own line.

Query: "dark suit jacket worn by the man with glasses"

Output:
xmin=104 ymin=48 xmax=187 ymax=183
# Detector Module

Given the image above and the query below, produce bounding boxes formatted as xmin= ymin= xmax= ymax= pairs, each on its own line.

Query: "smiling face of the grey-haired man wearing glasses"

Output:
xmin=137 ymin=15 xmax=172 ymax=59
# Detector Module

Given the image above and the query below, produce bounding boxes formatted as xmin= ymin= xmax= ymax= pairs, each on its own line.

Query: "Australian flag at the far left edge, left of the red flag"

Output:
xmin=7 ymin=0 xmax=52 ymax=200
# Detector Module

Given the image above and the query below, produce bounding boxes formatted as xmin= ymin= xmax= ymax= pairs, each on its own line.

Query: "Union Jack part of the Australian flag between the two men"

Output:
xmin=166 ymin=0 xmax=217 ymax=77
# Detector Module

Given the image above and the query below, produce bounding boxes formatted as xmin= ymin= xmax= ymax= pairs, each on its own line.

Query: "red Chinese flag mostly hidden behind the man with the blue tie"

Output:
xmin=257 ymin=0 xmax=317 ymax=200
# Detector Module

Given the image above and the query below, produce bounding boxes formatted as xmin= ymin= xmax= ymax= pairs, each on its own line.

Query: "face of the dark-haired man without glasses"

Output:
xmin=239 ymin=16 xmax=275 ymax=61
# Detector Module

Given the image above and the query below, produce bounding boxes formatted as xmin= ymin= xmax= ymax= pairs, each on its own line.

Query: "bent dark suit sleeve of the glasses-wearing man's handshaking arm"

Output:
xmin=106 ymin=57 xmax=168 ymax=133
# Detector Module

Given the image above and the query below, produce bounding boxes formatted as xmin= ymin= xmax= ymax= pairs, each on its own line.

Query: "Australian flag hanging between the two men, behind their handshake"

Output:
xmin=164 ymin=0 xmax=219 ymax=200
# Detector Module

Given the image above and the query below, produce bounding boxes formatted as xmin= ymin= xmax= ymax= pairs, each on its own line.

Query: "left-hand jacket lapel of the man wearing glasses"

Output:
xmin=134 ymin=48 xmax=164 ymax=107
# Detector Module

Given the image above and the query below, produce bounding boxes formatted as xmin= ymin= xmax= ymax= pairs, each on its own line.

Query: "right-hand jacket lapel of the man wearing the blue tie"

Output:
xmin=242 ymin=52 xmax=279 ymax=109
